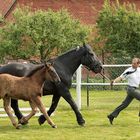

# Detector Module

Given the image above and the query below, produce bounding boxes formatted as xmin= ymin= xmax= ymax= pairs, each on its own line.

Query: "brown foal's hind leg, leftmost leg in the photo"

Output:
xmin=3 ymin=97 xmax=21 ymax=129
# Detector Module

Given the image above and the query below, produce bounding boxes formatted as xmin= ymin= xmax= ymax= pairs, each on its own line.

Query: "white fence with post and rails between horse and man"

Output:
xmin=73 ymin=64 xmax=131 ymax=110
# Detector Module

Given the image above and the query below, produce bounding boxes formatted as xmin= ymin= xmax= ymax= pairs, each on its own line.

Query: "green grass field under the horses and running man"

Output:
xmin=0 ymin=90 xmax=140 ymax=140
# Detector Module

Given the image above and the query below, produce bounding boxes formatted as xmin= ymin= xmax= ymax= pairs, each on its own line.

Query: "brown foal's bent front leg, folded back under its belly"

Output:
xmin=19 ymin=101 xmax=37 ymax=123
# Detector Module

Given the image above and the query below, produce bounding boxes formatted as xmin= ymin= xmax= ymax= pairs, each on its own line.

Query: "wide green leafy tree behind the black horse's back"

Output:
xmin=0 ymin=7 xmax=90 ymax=60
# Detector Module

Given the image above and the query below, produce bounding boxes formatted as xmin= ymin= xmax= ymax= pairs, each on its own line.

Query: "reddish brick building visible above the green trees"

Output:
xmin=0 ymin=0 xmax=140 ymax=24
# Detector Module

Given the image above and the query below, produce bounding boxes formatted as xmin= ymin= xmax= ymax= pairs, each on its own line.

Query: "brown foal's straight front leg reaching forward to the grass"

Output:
xmin=33 ymin=96 xmax=57 ymax=128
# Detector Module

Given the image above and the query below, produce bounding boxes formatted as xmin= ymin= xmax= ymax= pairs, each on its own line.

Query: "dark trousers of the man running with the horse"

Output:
xmin=110 ymin=86 xmax=140 ymax=118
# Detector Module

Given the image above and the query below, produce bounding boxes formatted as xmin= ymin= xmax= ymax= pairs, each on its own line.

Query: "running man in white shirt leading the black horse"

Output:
xmin=107 ymin=58 xmax=140 ymax=124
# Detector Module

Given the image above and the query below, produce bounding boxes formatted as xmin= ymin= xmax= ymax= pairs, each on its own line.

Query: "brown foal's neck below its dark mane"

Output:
xmin=31 ymin=68 xmax=46 ymax=86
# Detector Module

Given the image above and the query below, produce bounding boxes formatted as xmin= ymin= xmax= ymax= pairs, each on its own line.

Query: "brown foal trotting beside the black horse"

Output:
xmin=0 ymin=63 xmax=60 ymax=129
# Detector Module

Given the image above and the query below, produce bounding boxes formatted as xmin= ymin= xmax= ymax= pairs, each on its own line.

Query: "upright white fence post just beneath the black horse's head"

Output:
xmin=76 ymin=65 xmax=81 ymax=110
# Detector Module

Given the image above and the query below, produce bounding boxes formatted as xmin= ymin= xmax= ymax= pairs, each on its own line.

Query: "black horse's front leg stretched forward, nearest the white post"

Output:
xmin=56 ymin=83 xmax=85 ymax=125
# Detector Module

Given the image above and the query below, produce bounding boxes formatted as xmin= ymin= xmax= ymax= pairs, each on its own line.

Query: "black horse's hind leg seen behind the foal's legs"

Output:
xmin=11 ymin=99 xmax=28 ymax=125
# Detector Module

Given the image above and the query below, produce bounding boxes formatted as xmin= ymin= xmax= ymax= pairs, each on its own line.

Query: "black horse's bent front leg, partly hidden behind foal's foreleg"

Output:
xmin=38 ymin=94 xmax=60 ymax=125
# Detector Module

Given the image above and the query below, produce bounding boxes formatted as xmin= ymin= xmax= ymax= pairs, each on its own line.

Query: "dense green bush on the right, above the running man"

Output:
xmin=97 ymin=0 xmax=140 ymax=57
